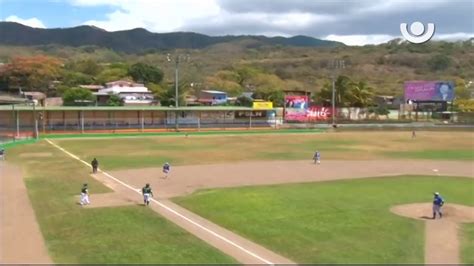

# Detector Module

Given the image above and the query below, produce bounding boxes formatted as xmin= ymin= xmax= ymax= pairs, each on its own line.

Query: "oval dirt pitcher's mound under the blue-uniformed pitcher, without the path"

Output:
xmin=390 ymin=203 xmax=474 ymax=223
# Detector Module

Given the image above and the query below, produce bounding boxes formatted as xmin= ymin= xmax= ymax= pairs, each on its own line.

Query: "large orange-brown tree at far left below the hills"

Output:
xmin=0 ymin=55 xmax=61 ymax=92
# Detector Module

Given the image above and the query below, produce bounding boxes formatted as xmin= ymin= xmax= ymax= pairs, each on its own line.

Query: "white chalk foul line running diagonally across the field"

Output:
xmin=45 ymin=139 xmax=274 ymax=265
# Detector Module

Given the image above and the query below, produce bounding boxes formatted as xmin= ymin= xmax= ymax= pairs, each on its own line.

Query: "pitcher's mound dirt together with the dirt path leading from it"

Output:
xmin=391 ymin=203 xmax=474 ymax=264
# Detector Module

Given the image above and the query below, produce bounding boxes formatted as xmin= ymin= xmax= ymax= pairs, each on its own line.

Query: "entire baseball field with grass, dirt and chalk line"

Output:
xmin=0 ymin=131 xmax=474 ymax=264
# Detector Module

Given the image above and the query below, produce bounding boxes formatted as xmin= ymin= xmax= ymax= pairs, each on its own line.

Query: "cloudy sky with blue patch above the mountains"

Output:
xmin=0 ymin=0 xmax=474 ymax=45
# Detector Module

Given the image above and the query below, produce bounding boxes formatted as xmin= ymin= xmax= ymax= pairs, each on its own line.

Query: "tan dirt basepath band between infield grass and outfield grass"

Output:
xmin=111 ymin=160 xmax=474 ymax=198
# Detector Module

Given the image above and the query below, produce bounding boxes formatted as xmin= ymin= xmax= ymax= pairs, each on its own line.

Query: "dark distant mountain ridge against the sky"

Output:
xmin=0 ymin=22 xmax=343 ymax=53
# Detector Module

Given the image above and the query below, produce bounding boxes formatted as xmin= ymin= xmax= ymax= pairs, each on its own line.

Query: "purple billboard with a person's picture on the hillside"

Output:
xmin=405 ymin=81 xmax=454 ymax=102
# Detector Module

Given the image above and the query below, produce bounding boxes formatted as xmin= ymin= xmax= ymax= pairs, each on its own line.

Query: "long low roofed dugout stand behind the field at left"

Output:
xmin=0 ymin=105 xmax=276 ymax=137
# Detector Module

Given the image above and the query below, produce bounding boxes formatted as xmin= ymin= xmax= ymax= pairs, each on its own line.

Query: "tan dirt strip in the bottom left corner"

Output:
xmin=0 ymin=161 xmax=51 ymax=263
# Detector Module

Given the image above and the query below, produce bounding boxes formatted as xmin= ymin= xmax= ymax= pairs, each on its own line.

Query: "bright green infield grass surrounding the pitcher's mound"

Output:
xmin=174 ymin=176 xmax=474 ymax=263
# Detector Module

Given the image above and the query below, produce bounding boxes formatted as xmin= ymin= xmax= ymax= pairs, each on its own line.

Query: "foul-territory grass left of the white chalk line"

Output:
xmin=3 ymin=141 xmax=235 ymax=264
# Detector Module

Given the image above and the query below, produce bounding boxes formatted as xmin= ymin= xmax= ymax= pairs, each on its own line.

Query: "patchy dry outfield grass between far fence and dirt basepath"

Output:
xmin=49 ymin=132 xmax=474 ymax=170
